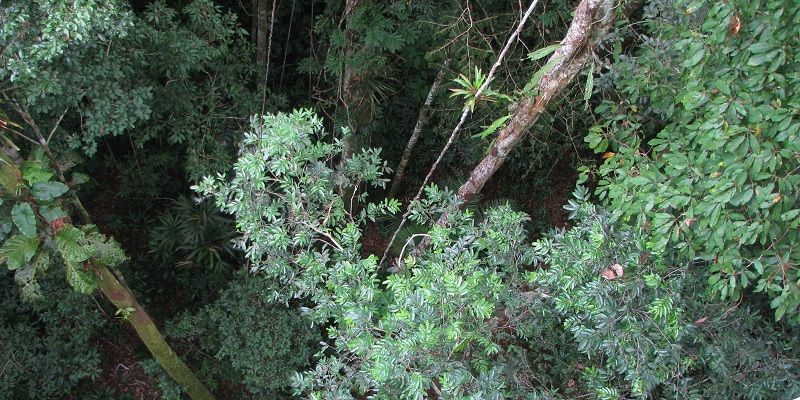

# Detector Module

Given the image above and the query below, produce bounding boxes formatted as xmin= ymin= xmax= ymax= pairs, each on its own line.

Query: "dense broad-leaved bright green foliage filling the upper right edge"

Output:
xmin=586 ymin=1 xmax=800 ymax=323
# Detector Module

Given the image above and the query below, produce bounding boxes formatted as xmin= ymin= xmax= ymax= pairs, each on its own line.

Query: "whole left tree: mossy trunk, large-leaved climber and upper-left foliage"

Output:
xmin=0 ymin=2 xmax=225 ymax=399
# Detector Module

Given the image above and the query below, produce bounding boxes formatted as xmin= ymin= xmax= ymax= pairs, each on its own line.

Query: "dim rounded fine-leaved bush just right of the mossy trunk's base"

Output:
xmin=168 ymin=276 xmax=320 ymax=398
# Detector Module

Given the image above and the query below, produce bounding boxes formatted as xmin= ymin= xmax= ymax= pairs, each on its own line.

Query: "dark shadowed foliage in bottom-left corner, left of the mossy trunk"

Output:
xmin=0 ymin=263 xmax=102 ymax=400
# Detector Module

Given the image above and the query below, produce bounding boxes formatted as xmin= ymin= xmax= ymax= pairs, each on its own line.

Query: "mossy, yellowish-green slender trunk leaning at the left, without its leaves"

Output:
xmin=2 ymin=101 xmax=214 ymax=400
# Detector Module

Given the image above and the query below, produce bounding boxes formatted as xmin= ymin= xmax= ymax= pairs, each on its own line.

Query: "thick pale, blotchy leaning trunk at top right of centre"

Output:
xmin=454 ymin=0 xmax=613 ymax=209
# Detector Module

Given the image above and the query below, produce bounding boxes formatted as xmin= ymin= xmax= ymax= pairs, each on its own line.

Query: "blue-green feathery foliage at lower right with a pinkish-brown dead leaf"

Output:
xmin=526 ymin=188 xmax=800 ymax=399
